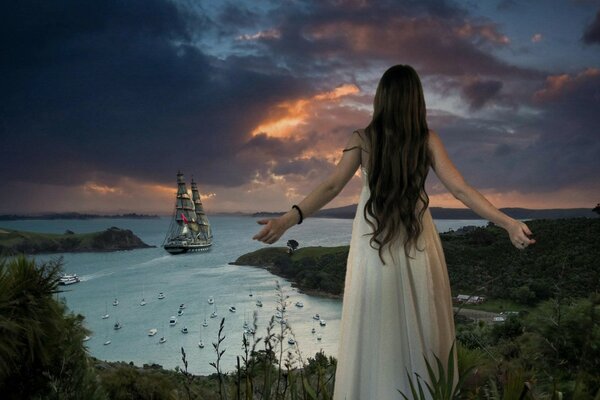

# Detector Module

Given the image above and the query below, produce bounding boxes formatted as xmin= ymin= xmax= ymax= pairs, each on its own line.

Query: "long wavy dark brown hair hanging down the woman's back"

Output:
xmin=364 ymin=65 xmax=432 ymax=264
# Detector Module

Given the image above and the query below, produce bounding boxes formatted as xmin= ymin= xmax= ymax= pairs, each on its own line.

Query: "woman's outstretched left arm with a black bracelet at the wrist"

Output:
xmin=252 ymin=132 xmax=361 ymax=244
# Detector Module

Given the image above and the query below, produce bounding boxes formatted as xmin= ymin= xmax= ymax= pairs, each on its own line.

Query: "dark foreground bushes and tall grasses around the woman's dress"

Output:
xmin=0 ymin=217 xmax=600 ymax=400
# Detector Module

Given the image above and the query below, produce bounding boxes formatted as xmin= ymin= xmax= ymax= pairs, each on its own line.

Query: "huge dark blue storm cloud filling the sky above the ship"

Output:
xmin=0 ymin=0 xmax=309 ymax=186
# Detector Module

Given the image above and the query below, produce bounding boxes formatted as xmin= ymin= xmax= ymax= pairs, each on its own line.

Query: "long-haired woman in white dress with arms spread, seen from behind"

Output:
xmin=253 ymin=65 xmax=535 ymax=400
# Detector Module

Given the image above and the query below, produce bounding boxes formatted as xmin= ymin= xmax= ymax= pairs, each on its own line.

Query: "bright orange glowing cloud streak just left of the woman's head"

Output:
xmin=252 ymin=83 xmax=360 ymax=138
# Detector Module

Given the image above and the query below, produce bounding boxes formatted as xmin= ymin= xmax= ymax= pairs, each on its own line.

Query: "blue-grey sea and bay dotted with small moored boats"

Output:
xmin=0 ymin=215 xmax=487 ymax=375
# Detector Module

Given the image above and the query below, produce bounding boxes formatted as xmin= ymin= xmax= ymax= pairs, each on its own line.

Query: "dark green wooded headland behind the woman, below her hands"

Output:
xmin=231 ymin=217 xmax=600 ymax=304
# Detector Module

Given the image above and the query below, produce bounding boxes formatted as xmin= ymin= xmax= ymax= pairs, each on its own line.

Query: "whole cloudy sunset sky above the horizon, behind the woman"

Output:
xmin=0 ymin=0 xmax=600 ymax=214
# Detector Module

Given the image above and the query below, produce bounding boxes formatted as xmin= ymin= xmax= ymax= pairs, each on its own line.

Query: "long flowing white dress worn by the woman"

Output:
xmin=333 ymin=168 xmax=458 ymax=400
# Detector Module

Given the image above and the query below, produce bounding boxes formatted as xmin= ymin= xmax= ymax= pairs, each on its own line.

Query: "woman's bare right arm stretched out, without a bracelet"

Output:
xmin=429 ymin=131 xmax=535 ymax=249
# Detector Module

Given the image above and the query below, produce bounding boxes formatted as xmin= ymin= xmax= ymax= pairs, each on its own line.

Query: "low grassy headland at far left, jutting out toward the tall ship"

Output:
xmin=0 ymin=226 xmax=156 ymax=256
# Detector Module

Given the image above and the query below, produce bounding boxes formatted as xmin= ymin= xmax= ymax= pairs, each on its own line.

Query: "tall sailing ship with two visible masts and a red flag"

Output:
xmin=163 ymin=171 xmax=213 ymax=254
